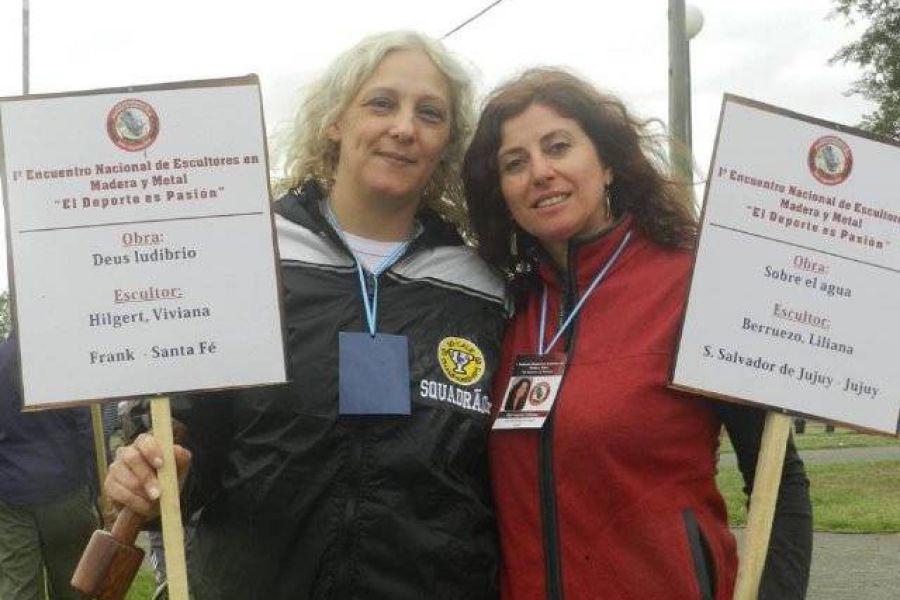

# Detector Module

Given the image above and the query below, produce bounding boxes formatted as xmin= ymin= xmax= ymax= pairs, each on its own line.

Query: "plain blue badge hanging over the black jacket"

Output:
xmin=338 ymin=331 xmax=410 ymax=415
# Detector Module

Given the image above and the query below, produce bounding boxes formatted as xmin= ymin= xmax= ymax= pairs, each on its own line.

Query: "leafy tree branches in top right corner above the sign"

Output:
xmin=830 ymin=0 xmax=900 ymax=139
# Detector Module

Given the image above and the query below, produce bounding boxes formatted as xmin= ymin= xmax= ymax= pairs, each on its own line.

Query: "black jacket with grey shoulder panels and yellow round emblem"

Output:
xmin=176 ymin=188 xmax=504 ymax=600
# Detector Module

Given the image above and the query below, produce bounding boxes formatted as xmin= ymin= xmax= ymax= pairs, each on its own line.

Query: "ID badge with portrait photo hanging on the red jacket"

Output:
xmin=493 ymin=353 xmax=566 ymax=429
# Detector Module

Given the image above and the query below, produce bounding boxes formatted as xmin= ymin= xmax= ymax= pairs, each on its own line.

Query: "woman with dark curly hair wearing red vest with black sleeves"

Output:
xmin=463 ymin=69 xmax=811 ymax=600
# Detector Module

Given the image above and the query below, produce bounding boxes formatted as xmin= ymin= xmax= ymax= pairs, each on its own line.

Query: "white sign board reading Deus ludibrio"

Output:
xmin=0 ymin=76 xmax=285 ymax=407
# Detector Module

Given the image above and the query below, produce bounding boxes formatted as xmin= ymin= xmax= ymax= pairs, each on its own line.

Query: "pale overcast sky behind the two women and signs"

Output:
xmin=0 ymin=0 xmax=873 ymax=289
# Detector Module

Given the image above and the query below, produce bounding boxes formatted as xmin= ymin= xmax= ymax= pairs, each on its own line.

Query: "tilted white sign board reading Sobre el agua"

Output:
xmin=672 ymin=96 xmax=900 ymax=434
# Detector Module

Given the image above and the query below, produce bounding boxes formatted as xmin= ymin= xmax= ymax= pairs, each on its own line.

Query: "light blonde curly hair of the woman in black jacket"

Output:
xmin=273 ymin=31 xmax=475 ymax=222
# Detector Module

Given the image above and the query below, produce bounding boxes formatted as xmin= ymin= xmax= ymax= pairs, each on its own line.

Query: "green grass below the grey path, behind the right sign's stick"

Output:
xmin=717 ymin=460 xmax=900 ymax=533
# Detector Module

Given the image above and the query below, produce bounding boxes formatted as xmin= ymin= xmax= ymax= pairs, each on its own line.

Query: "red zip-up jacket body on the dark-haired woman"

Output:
xmin=490 ymin=218 xmax=737 ymax=600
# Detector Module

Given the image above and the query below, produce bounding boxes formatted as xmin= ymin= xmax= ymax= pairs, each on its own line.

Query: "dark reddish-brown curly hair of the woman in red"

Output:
xmin=463 ymin=68 xmax=697 ymax=280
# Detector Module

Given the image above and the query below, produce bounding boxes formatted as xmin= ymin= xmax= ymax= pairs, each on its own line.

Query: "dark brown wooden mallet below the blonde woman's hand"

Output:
xmin=72 ymin=508 xmax=144 ymax=600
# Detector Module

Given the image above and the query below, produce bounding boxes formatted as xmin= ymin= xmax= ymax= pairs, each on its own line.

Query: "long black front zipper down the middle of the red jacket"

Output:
xmin=538 ymin=245 xmax=578 ymax=600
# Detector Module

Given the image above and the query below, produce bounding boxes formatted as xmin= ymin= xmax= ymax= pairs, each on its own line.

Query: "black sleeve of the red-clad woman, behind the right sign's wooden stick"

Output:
xmin=717 ymin=403 xmax=812 ymax=600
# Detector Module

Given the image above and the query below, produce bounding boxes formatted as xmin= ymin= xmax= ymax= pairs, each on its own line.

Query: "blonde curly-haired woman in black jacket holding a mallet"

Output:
xmin=106 ymin=32 xmax=504 ymax=600
